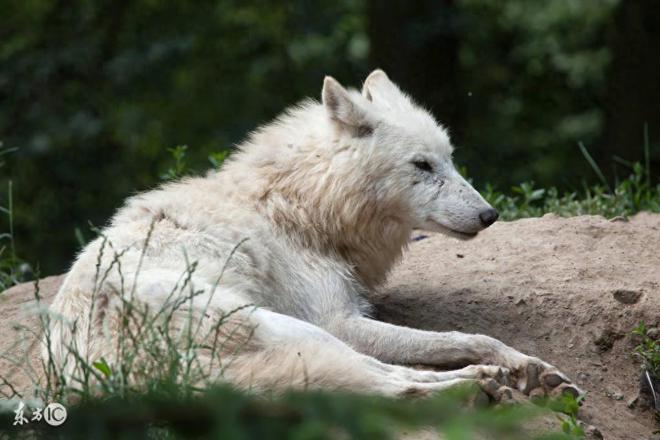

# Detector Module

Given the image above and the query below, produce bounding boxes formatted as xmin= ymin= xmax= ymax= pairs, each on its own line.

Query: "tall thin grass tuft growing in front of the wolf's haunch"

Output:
xmin=27 ymin=226 xmax=258 ymax=400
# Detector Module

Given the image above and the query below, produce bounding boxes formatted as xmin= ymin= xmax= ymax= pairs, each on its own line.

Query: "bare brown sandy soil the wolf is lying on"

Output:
xmin=0 ymin=213 xmax=660 ymax=440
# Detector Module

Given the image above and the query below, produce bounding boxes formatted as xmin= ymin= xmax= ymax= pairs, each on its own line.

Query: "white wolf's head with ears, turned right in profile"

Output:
xmin=322 ymin=70 xmax=498 ymax=238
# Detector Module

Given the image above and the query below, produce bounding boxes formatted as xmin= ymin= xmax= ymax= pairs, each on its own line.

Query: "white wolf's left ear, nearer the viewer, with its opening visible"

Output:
xmin=322 ymin=76 xmax=373 ymax=136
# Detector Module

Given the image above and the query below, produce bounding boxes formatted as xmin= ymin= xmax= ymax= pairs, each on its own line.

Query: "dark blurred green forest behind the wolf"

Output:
xmin=0 ymin=0 xmax=660 ymax=274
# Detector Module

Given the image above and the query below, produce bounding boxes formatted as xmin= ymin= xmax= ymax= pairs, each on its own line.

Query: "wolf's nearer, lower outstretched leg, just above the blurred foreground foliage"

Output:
xmin=217 ymin=309 xmax=508 ymax=401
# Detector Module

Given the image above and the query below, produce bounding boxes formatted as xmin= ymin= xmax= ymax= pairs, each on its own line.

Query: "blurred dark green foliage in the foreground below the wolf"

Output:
xmin=0 ymin=385 xmax=574 ymax=440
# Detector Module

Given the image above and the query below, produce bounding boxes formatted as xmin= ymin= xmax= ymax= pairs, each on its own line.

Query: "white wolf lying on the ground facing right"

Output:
xmin=46 ymin=70 xmax=579 ymax=399
